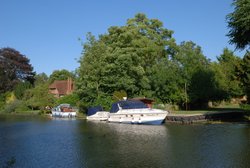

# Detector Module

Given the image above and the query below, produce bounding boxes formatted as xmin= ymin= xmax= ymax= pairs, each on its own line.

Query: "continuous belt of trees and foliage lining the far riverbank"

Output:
xmin=0 ymin=11 xmax=250 ymax=112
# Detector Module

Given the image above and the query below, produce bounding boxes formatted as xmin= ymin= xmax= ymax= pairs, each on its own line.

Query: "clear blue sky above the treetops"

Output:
xmin=0 ymin=0 xmax=244 ymax=75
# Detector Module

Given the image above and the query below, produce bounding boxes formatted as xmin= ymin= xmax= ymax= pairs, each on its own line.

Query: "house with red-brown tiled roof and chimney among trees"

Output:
xmin=49 ymin=78 xmax=74 ymax=98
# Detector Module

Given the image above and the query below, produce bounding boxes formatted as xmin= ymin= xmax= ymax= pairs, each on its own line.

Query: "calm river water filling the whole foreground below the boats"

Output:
xmin=0 ymin=116 xmax=250 ymax=168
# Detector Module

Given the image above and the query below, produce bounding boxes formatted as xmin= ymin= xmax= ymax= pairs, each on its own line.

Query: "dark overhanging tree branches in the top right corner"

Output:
xmin=227 ymin=0 xmax=250 ymax=49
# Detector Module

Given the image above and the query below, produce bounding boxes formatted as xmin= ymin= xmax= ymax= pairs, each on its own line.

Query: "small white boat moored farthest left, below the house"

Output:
xmin=51 ymin=104 xmax=76 ymax=117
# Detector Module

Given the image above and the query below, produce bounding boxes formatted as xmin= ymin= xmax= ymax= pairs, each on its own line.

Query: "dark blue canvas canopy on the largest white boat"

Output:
xmin=110 ymin=100 xmax=148 ymax=113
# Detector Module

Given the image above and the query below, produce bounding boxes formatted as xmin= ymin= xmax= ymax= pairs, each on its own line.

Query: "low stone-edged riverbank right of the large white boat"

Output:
xmin=165 ymin=111 xmax=250 ymax=124
